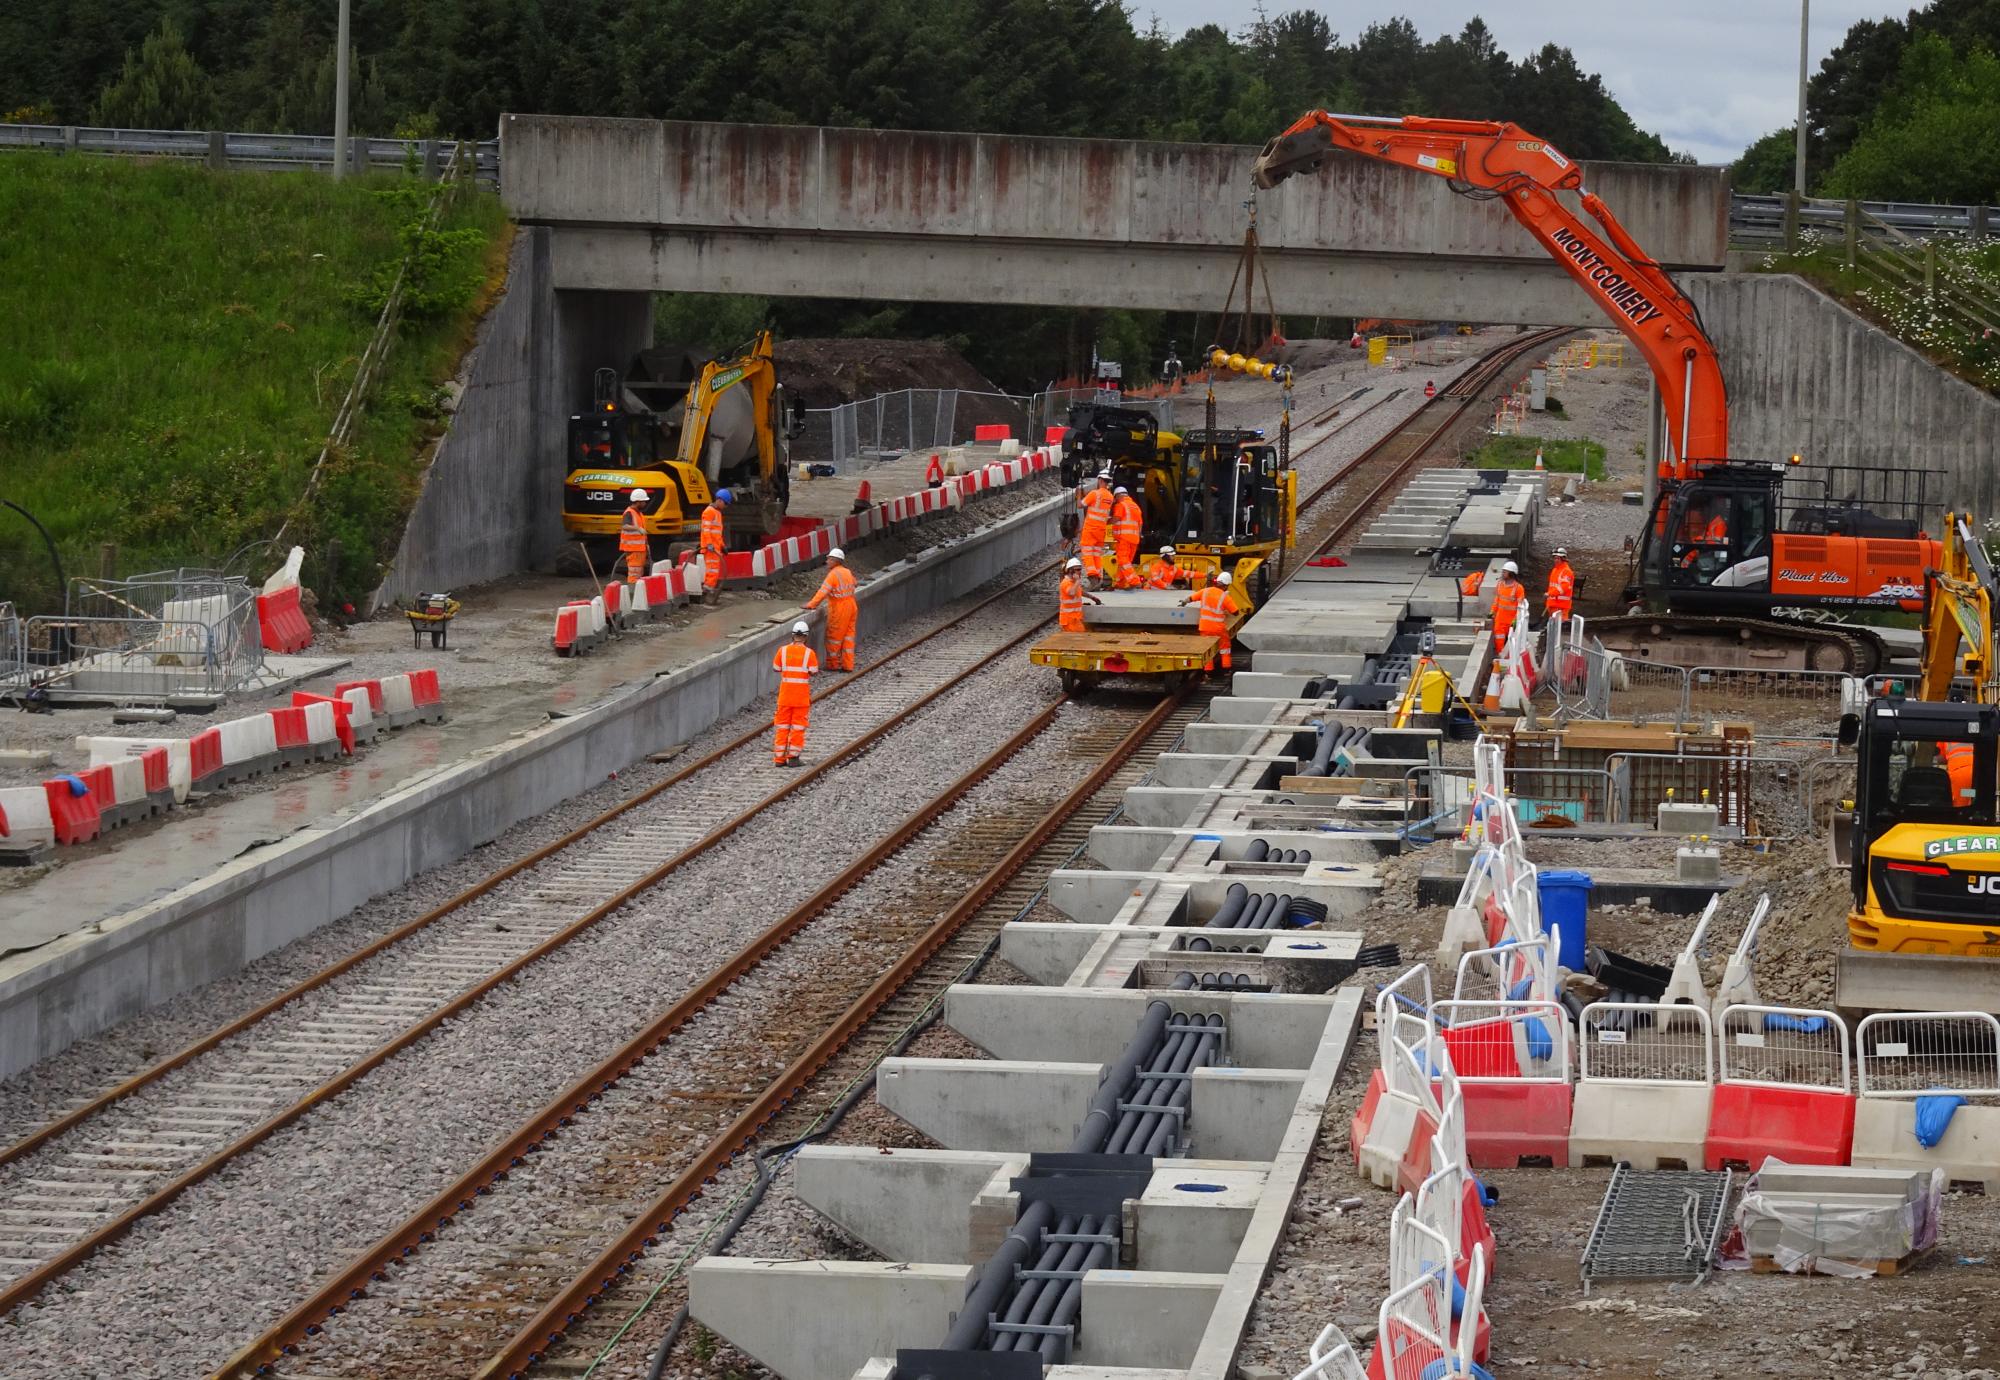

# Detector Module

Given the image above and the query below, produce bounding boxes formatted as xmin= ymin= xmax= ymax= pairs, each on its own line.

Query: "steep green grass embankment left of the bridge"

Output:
xmin=0 ymin=154 xmax=508 ymax=612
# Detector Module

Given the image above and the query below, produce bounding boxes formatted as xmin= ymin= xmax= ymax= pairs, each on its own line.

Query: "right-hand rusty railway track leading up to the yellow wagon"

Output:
xmin=216 ymin=698 xmax=1198 ymax=1378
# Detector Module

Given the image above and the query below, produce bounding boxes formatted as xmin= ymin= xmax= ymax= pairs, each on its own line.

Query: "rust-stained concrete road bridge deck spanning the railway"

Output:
xmin=500 ymin=114 xmax=1730 ymax=326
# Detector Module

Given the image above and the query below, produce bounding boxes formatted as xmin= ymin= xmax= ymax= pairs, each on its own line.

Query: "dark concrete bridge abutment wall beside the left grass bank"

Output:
xmin=374 ymin=226 xmax=652 ymax=608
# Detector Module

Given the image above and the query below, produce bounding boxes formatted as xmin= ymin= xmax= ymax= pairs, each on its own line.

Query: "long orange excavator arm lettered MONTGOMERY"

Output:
xmin=1254 ymin=110 xmax=1730 ymax=478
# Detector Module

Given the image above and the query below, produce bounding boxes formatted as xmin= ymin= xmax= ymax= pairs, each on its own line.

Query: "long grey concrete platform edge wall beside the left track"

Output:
xmin=0 ymin=496 xmax=1064 ymax=1078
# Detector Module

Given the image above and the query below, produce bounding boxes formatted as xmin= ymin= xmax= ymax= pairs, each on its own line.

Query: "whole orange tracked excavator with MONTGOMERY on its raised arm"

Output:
xmin=1254 ymin=110 xmax=1942 ymax=674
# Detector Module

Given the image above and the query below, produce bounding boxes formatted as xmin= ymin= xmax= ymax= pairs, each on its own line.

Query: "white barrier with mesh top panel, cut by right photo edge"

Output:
xmin=1852 ymin=1012 xmax=2000 ymax=1196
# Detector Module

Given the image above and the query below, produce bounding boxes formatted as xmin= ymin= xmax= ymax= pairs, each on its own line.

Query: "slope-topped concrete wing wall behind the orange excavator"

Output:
xmin=1680 ymin=274 xmax=2000 ymax=514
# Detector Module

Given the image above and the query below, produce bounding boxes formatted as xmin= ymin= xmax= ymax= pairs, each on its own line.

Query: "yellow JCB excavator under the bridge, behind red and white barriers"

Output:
xmin=562 ymin=330 xmax=804 ymax=548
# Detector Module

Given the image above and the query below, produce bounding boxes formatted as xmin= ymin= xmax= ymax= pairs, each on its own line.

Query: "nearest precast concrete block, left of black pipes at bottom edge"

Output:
xmin=688 ymin=1256 xmax=974 ymax=1380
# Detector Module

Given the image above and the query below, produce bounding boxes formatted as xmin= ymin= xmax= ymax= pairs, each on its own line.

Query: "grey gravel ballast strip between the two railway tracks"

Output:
xmin=0 ymin=636 xmax=1082 ymax=1376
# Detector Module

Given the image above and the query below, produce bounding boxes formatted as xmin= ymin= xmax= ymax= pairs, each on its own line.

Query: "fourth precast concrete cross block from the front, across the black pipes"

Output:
xmin=932 ymin=984 xmax=1340 ymax=1072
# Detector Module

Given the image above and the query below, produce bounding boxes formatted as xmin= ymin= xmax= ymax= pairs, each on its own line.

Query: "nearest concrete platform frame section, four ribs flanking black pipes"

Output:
xmin=688 ymin=986 xmax=1362 ymax=1380
